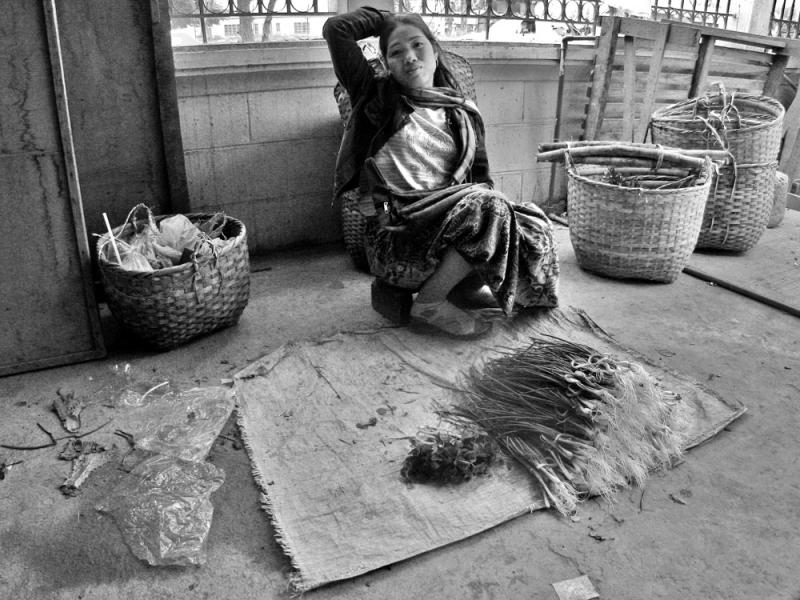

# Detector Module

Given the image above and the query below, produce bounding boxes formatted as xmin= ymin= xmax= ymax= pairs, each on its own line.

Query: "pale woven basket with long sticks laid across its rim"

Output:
xmin=566 ymin=150 xmax=712 ymax=283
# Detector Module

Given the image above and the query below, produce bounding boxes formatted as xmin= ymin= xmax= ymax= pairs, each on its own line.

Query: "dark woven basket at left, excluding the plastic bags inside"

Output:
xmin=97 ymin=214 xmax=250 ymax=350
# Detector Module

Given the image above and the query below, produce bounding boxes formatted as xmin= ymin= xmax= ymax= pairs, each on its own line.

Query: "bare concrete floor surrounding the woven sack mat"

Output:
xmin=0 ymin=227 xmax=800 ymax=600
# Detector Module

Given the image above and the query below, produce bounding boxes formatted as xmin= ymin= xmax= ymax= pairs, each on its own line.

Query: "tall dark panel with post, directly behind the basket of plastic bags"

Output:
xmin=57 ymin=0 xmax=183 ymax=246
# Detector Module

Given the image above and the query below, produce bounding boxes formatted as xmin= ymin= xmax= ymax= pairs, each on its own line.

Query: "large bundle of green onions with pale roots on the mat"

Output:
xmin=453 ymin=336 xmax=682 ymax=514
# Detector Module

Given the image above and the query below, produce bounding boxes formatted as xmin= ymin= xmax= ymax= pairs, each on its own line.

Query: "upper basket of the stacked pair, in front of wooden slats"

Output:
xmin=650 ymin=91 xmax=786 ymax=164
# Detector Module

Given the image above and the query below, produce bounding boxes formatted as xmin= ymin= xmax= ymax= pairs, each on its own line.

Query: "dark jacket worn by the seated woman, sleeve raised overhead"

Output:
xmin=322 ymin=7 xmax=492 ymax=197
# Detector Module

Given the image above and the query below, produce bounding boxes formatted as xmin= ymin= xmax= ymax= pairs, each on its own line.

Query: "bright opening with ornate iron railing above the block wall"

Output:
xmin=170 ymin=0 xmax=736 ymax=44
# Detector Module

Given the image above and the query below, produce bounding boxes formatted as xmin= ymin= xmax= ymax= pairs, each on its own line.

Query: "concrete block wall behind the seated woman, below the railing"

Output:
xmin=170 ymin=43 xmax=591 ymax=252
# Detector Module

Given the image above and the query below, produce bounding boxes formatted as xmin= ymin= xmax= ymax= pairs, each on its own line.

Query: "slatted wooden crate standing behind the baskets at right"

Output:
xmin=551 ymin=17 xmax=800 ymax=188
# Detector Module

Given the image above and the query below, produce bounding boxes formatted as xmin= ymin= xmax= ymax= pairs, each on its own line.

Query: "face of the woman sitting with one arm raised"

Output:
xmin=386 ymin=24 xmax=438 ymax=89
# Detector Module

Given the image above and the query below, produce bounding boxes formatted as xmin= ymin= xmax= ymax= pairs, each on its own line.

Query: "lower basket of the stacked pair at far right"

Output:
xmin=697 ymin=162 xmax=778 ymax=252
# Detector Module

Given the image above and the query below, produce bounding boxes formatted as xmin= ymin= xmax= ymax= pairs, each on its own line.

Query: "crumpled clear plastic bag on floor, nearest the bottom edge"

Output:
xmin=97 ymin=454 xmax=225 ymax=566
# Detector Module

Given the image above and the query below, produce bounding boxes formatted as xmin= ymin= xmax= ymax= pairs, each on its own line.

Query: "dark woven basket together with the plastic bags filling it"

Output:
xmin=97 ymin=204 xmax=250 ymax=350
